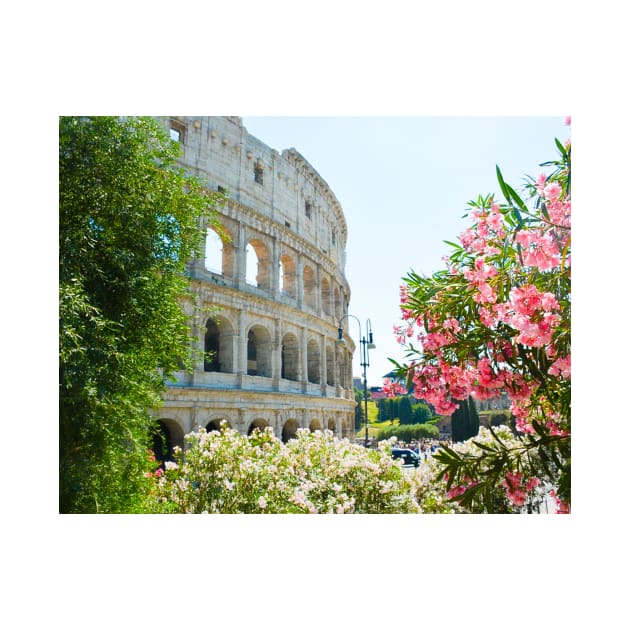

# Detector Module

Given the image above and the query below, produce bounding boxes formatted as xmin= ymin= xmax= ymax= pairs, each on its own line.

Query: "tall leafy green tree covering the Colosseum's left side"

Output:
xmin=59 ymin=117 xmax=224 ymax=513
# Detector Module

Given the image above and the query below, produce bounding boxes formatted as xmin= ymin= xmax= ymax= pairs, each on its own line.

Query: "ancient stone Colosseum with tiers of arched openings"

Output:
xmin=156 ymin=116 xmax=355 ymax=450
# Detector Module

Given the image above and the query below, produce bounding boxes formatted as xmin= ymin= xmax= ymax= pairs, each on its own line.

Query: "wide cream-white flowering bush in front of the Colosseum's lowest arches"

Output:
xmin=147 ymin=427 xmax=419 ymax=514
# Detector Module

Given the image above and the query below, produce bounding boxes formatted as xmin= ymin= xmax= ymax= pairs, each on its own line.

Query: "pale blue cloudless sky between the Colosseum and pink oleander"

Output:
xmin=243 ymin=112 xmax=571 ymax=386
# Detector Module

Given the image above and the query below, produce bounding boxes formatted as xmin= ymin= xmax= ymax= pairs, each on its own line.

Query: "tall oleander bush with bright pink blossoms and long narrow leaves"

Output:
xmin=395 ymin=122 xmax=571 ymax=511
